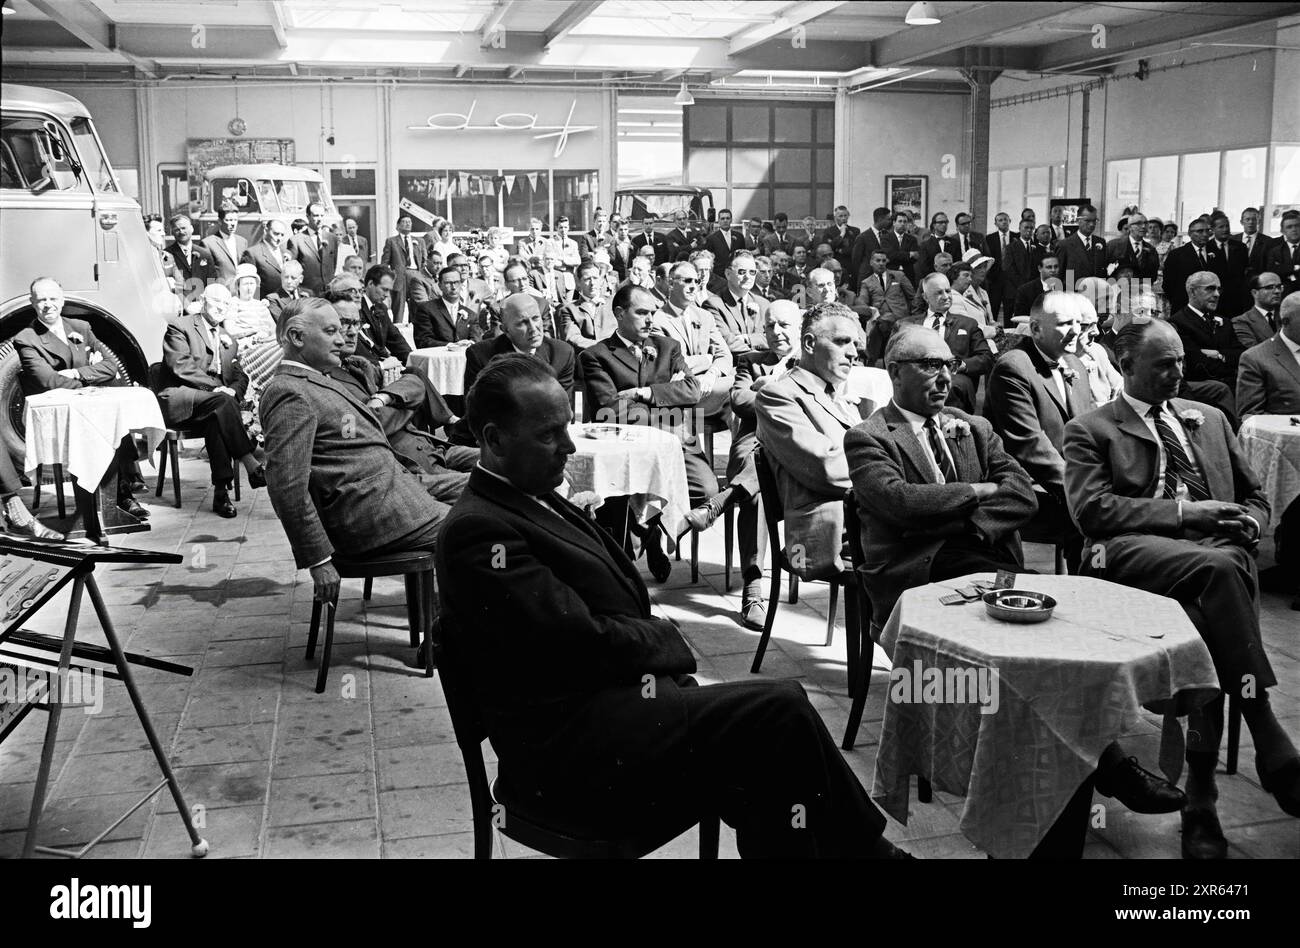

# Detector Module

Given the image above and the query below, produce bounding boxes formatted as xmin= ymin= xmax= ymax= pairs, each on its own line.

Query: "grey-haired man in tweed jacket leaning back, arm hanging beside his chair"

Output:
xmin=261 ymin=299 xmax=450 ymax=602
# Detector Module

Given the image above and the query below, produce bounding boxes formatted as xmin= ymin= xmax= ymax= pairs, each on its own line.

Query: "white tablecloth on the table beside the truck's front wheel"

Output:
xmin=23 ymin=388 xmax=166 ymax=489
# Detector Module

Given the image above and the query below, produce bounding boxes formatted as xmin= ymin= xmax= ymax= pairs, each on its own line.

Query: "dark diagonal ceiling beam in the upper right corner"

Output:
xmin=1036 ymin=3 xmax=1300 ymax=73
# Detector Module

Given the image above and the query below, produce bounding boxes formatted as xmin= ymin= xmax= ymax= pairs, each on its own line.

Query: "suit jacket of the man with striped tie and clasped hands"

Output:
xmin=1065 ymin=397 xmax=1269 ymax=540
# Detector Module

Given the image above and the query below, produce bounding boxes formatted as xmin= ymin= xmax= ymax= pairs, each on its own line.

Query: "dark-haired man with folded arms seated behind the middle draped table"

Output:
xmin=579 ymin=283 xmax=725 ymax=583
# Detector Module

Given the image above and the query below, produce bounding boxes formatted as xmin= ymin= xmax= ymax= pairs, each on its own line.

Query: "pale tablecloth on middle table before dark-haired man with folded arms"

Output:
xmin=560 ymin=425 xmax=690 ymax=545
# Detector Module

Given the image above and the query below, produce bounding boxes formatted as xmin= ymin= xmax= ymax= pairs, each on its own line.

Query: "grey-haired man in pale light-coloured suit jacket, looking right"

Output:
xmin=754 ymin=303 xmax=879 ymax=580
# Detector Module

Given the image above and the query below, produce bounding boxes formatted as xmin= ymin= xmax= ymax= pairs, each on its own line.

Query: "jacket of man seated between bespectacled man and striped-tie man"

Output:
xmin=984 ymin=336 xmax=1097 ymax=499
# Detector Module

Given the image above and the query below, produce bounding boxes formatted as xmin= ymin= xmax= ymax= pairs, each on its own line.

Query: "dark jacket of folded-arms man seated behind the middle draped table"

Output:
xmin=577 ymin=334 xmax=701 ymax=426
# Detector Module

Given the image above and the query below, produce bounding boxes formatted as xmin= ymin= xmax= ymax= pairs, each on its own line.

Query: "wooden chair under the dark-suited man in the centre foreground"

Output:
xmin=432 ymin=612 xmax=722 ymax=860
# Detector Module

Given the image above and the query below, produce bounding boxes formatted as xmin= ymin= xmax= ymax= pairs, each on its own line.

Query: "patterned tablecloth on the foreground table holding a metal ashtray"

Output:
xmin=872 ymin=573 xmax=1218 ymax=858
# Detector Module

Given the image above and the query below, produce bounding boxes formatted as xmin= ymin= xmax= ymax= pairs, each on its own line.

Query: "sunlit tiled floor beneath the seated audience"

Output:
xmin=0 ymin=446 xmax=1300 ymax=858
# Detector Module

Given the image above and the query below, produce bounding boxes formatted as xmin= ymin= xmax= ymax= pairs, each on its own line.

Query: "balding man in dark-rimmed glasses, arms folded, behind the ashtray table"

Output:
xmin=847 ymin=325 xmax=1037 ymax=627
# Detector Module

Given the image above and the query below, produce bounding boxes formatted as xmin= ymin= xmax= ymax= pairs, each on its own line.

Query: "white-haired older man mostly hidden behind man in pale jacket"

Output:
xmin=727 ymin=299 xmax=802 ymax=631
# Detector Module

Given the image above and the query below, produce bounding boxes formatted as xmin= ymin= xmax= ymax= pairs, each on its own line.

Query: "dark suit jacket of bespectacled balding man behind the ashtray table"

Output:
xmin=844 ymin=402 xmax=1037 ymax=625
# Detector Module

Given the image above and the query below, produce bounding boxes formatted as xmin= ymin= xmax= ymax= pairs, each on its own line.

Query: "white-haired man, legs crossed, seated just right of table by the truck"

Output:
xmin=157 ymin=283 xmax=267 ymax=519
